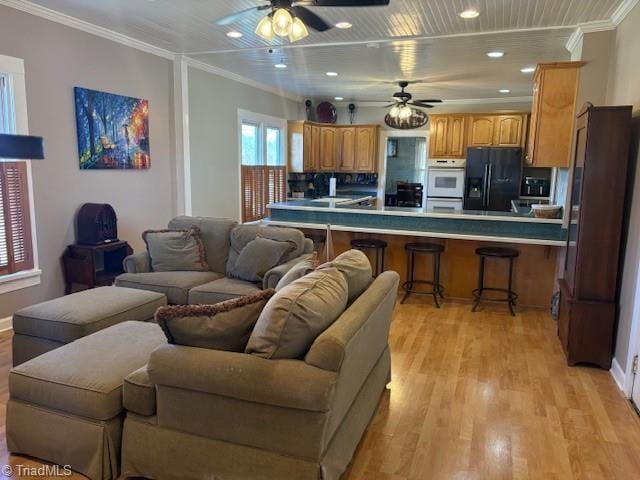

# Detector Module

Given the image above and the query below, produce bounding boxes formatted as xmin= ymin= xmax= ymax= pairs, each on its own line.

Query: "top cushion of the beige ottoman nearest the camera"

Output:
xmin=9 ymin=322 xmax=165 ymax=420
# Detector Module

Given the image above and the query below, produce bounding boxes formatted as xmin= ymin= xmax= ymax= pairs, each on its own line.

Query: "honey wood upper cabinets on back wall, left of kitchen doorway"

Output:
xmin=298 ymin=122 xmax=378 ymax=173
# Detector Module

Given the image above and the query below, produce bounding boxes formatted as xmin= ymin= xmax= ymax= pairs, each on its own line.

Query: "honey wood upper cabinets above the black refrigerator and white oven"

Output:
xmin=429 ymin=112 xmax=528 ymax=158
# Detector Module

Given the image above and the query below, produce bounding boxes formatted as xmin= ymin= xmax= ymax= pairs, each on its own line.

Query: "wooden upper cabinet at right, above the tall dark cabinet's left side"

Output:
xmin=525 ymin=62 xmax=583 ymax=167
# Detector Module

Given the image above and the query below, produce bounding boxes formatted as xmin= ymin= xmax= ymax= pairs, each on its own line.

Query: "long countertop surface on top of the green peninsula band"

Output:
xmin=268 ymin=196 xmax=562 ymax=225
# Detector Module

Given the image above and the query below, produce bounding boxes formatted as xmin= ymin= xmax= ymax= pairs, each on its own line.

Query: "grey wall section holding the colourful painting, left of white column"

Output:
xmin=0 ymin=6 xmax=175 ymax=319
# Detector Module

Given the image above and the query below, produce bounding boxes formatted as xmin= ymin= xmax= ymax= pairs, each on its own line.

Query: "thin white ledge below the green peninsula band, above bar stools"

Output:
xmin=263 ymin=219 xmax=566 ymax=247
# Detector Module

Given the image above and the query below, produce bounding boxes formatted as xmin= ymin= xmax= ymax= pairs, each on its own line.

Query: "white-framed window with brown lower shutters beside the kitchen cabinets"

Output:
xmin=239 ymin=111 xmax=287 ymax=222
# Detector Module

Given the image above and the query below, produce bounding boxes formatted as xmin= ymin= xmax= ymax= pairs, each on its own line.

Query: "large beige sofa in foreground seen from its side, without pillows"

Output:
xmin=122 ymin=272 xmax=399 ymax=480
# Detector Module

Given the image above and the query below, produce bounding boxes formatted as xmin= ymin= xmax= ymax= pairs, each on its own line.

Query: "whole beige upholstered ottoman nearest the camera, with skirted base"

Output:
xmin=6 ymin=322 xmax=166 ymax=480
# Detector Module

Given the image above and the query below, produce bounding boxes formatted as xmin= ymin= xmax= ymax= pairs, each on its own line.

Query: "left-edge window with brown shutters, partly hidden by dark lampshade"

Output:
xmin=0 ymin=55 xmax=39 ymax=284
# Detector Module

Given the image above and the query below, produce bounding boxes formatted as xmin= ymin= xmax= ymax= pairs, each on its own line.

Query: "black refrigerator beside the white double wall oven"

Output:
xmin=464 ymin=147 xmax=522 ymax=212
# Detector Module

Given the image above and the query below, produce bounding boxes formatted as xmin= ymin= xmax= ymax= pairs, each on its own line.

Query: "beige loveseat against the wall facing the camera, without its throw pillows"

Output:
xmin=115 ymin=217 xmax=313 ymax=305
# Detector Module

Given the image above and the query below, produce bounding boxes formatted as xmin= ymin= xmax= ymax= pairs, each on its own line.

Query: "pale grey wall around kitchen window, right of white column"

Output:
xmin=188 ymin=68 xmax=300 ymax=220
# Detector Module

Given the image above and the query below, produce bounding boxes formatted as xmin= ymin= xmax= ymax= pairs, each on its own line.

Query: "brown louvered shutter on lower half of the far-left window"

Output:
xmin=0 ymin=162 xmax=33 ymax=275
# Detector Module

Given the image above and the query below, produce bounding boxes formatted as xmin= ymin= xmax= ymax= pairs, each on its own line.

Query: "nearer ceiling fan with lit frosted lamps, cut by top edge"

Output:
xmin=216 ymin=0 xmax=390 ymax=42
